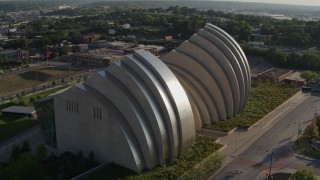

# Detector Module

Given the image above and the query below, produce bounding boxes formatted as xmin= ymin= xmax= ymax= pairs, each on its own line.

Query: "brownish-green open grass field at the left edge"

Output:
xmin=0 ymin=67 xmax=82 ymax=95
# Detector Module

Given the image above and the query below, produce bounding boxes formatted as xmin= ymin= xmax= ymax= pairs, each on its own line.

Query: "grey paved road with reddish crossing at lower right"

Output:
xmin=211 ymin=96 xmax=320 ymax=180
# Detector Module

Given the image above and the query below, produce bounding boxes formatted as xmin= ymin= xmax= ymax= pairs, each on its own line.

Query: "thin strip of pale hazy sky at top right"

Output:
xmin=235 ymin=0 xmax=320 ymax=6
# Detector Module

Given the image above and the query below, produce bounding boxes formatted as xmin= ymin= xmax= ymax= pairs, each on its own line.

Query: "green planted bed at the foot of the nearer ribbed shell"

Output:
xmin=87 ymin=136 xmax=223 ymax=180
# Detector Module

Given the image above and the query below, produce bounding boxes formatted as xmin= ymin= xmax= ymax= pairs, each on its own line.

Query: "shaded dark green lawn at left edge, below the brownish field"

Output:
xmin=0 ymin=115 xmax=38 ymax=142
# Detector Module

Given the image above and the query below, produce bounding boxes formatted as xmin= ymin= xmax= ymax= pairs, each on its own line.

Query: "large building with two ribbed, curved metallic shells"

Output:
xmin=35 ymin=24 xmax=250 ymax=172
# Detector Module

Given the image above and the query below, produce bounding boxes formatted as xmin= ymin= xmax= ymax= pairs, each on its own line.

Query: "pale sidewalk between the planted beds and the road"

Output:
xmin=206 ymin=92 xmax=309 ymax=177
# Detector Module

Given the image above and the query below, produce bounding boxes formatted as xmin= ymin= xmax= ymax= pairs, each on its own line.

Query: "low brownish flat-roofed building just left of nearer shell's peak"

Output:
xmin=76 ymin=48 xmax=124 ymax=68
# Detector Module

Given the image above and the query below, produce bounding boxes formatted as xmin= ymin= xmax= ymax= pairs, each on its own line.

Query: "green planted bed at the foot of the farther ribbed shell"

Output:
xmin=204 ymin=84 xmax=298 ymax=132
